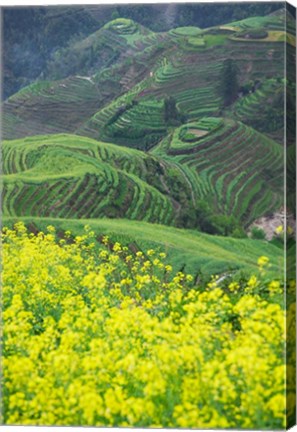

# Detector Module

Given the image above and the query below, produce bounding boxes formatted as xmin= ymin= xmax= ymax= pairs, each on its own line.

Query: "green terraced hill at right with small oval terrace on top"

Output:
xmin=153 ymin=120 xmax=283 ymax=225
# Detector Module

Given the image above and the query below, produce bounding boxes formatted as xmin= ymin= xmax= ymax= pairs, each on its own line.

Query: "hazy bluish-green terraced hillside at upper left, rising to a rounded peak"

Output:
xmin=3 ymin=19 xmax=172 ymax=139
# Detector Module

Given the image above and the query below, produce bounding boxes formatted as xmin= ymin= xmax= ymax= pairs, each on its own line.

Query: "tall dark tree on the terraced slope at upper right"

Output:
xmin=220 ymin=59 xmax=239 ymax=106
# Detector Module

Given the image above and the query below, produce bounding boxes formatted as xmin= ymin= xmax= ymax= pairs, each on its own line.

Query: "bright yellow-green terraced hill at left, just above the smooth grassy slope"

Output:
xmin=3 ymin=135 xmax=197 ymax=225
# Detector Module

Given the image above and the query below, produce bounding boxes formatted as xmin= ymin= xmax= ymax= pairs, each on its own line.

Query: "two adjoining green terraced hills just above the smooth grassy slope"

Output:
xmin=3 ymin=127 xmax=283 ymax=235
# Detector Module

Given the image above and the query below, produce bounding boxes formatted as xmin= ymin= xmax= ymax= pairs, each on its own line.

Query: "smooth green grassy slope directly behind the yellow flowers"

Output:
xmin=3 ymin=217 xmax=283 ymax=277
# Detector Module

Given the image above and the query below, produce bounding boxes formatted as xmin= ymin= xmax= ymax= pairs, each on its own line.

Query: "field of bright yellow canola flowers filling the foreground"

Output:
xmin=2 ymin=222 xmax=286 ymax=429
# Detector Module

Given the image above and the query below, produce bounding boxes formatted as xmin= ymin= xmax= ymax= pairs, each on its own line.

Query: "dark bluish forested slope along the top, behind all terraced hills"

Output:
xmin=2 ymin=2 xmax=283 ymax=98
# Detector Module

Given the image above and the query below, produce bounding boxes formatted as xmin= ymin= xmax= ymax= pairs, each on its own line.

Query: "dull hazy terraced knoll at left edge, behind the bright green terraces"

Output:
xmin=3 ymin=76 xmax=102 ymax=138
